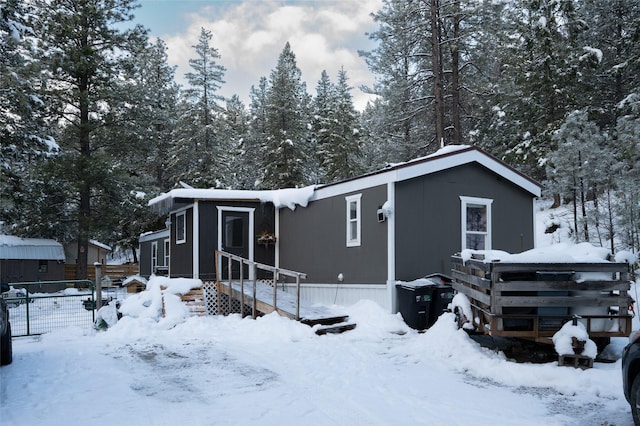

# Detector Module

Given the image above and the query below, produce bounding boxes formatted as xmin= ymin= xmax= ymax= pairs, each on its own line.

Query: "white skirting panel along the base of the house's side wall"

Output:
xmin=278 ymin=283 xmax=389 ymax=310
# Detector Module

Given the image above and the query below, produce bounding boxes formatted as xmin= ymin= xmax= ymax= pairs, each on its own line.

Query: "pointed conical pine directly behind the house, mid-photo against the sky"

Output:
xmin=261 ymin=42 xmax=310 ymax=189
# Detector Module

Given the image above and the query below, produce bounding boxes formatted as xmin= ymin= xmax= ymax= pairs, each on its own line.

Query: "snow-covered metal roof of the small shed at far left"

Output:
xmin=0 ymin=235 xmax=65 ymax=261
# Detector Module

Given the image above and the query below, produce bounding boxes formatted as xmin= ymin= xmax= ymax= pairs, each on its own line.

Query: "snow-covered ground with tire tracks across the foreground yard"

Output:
xmin=0 ymin=203 xmax=640 ymax=426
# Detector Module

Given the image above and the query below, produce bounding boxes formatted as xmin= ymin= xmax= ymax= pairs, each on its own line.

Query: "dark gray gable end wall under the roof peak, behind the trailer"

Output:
xmin=394 ymin=163 xmax=534 ymax=281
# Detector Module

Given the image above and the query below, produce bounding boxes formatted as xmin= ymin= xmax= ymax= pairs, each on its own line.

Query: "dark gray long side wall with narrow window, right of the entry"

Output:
xmin=279 ymin=185 xmax=388 ymax=284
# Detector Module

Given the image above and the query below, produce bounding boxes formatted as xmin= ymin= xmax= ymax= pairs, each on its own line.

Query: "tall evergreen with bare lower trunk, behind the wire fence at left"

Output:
xmin=38 ymin=0 xmax=146 ymax=278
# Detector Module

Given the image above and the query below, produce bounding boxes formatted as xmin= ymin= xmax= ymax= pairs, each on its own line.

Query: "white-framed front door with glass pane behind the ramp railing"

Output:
xmin=220 ymin=210 xmax=253 ymax=279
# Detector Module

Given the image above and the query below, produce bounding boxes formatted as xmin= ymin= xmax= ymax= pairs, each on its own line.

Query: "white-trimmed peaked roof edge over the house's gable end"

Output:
xmin=312 ymin=145 xmax=542 ymax=200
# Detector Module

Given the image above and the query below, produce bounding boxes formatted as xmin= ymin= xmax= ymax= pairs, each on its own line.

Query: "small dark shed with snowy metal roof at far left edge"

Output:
xmin=0 ymin=235 xmax=65 ymax=291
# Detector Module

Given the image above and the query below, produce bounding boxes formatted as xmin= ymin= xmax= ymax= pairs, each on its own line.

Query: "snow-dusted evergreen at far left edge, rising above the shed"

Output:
xmin=0 ymin=0 xmax=52 ymax=236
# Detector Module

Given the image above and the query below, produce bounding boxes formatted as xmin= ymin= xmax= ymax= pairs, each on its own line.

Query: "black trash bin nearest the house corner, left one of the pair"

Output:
xmin=396 ymin=280 xmax=435 ymax=330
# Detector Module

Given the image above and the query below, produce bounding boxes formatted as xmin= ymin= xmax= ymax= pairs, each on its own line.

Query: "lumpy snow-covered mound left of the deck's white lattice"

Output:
xmin=120 ymin=275 xmax=202 ymax=328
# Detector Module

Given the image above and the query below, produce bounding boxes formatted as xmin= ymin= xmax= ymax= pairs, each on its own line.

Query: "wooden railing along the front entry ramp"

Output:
xmin=215 ymin=250 xmax=307 ymax=320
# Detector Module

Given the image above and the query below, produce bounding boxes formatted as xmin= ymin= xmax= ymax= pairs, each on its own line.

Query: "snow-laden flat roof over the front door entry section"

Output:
xmin=149 ymin=185 xmax=315 ymax=214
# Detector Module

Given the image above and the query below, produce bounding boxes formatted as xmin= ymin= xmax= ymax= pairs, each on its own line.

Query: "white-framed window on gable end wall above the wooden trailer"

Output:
xmin=460 ymin=196 xmax=493 ymax=250
